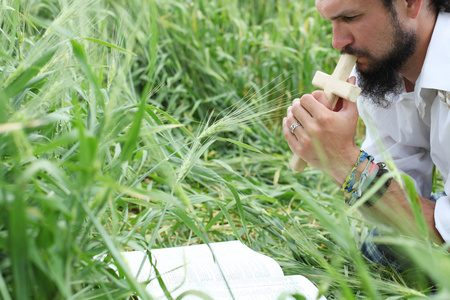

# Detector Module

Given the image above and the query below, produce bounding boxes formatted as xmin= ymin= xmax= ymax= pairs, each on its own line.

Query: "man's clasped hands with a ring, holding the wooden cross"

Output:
xmin=283 ymin=78 xmax=360 ymax=184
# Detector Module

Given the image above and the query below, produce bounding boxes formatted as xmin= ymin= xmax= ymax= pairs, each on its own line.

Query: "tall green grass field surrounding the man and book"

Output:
xmin=0 ymin=0 xmax=450 ymax=300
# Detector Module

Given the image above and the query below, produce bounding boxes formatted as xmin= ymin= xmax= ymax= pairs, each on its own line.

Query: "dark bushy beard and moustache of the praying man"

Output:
xmin=341 ymin=11 xmax=417 ymax=107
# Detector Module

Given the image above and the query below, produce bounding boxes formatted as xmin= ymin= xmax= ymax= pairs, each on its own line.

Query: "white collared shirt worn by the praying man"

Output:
xmin=358 ymin=13 xmax=450 ymax=242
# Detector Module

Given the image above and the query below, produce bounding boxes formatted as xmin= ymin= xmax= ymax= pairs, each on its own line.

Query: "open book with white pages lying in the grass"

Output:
xmin=122 ymin=241 xmax=326 ymax=300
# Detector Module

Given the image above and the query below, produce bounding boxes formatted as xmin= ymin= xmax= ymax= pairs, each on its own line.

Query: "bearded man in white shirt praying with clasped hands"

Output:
xmin=283 ymin=0 xmax=450 ymax=264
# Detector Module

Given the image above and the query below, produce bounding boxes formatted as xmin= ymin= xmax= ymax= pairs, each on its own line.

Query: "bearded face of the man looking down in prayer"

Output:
xmin=316 ymin=0 xmax=417 ymax=106
